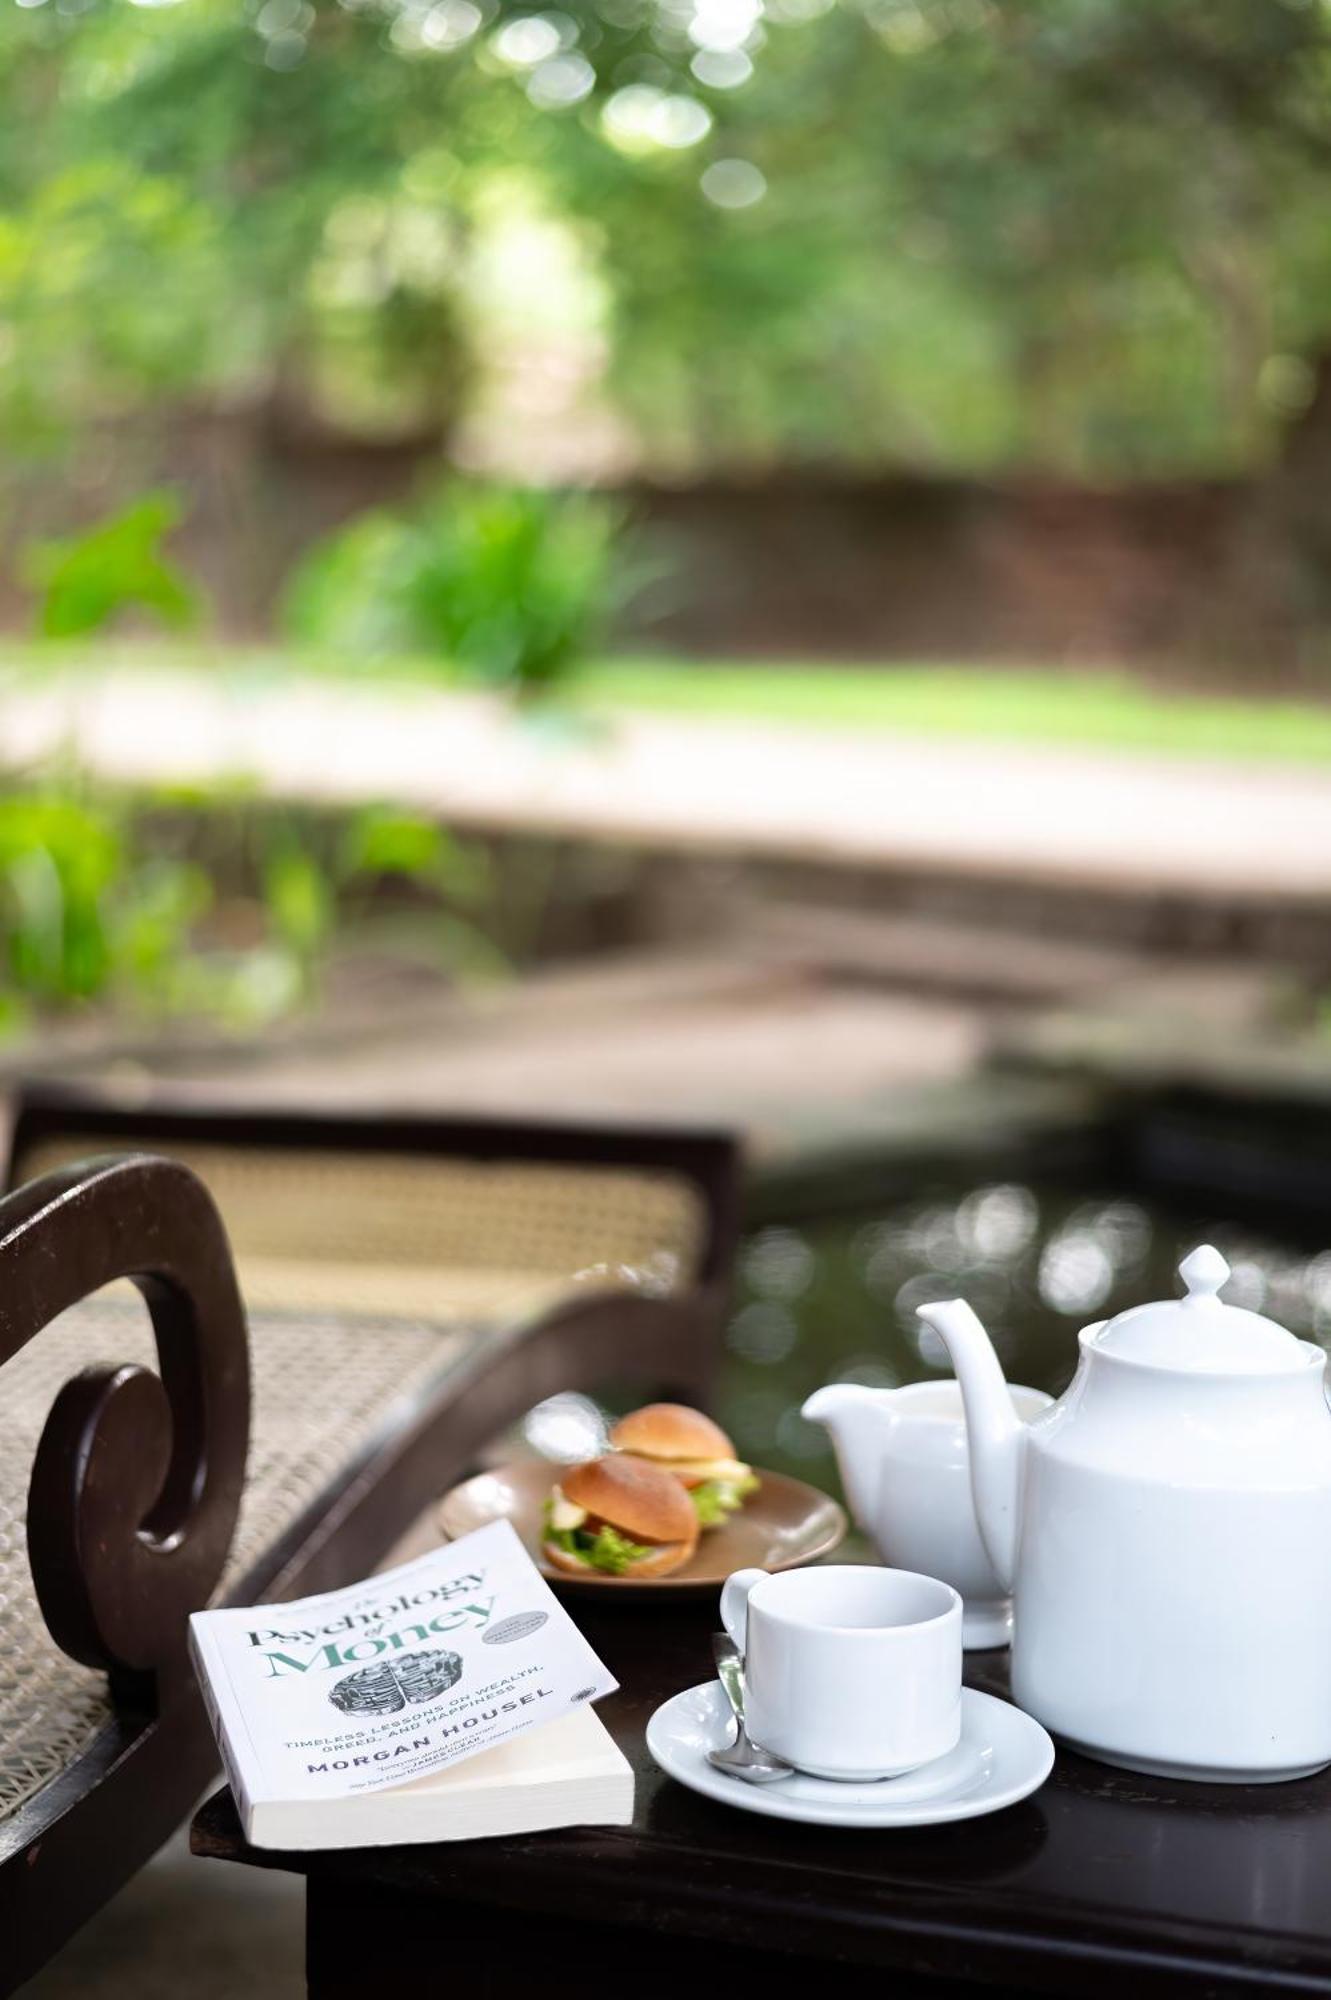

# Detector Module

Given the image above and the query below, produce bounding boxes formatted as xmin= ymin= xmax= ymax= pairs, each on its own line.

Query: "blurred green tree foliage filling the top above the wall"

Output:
xmin=0 ymin=0 xmax=1331 ymax=476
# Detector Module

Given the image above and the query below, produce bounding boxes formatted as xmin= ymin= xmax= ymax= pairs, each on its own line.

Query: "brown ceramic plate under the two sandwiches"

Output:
xmin=438 ymin=1458 xmax=845 ymax=1596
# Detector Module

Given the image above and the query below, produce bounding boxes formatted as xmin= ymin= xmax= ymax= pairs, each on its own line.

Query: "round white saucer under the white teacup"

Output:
xmin=648 ymin=1680 xmax=1053 ymax=1826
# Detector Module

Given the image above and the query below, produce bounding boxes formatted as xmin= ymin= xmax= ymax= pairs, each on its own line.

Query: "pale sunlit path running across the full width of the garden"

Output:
xmin=0 ymin=672 xmax=1331 ymax=900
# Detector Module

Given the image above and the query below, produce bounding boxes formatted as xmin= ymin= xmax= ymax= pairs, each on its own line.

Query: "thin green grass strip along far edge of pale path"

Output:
xmin=0 ymin=642 xmax=1331 ymax=764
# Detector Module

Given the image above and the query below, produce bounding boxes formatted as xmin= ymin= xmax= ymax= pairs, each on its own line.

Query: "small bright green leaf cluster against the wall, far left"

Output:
xmin=20 ymin=494 xmax=198 ymax=638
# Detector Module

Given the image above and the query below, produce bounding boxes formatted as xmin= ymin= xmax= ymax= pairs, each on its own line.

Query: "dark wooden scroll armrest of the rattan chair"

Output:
xmin=0 ymin=1154 xmax=250 ymax=1674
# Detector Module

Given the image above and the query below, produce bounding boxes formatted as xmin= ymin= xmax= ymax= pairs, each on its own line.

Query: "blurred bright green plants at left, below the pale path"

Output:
xmin=0 ymin=774 xmax=502 ymax=1034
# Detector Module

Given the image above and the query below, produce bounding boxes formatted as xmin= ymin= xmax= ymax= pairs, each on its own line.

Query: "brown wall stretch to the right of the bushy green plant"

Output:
xmin=636 ymin=478 xmax=1249 ymax=662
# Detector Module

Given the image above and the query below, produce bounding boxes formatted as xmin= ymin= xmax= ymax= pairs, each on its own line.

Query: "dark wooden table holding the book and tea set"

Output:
xmin=194 ymin=1600 xmax=1331 ymax=2000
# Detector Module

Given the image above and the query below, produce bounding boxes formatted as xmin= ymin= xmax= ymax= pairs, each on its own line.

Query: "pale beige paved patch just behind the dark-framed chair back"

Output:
xmin=165 ymin=952 xmax=989 ymax=1164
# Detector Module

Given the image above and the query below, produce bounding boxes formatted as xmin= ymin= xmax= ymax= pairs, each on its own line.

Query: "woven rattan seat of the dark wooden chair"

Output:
xmin=0 ymin=1296 xmax=484 ymax=1820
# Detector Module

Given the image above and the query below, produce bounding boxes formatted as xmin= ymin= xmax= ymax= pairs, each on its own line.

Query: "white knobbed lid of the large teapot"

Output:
xmin=1091 ymin=1244 xmax=1305 ymax=1374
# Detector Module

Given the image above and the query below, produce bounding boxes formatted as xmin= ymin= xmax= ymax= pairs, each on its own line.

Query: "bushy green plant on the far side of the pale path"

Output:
xmin=288 ymin=480 xmax=628 ymax=698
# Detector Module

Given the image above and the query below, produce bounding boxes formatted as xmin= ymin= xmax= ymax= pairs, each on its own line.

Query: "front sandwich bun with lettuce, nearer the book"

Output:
xmin=542 ymin=1452 xmax=697 ymax=1578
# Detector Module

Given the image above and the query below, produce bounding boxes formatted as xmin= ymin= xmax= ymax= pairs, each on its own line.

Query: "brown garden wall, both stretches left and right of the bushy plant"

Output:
xmin=0 ymin=412 xmax=1285 ymax=664
